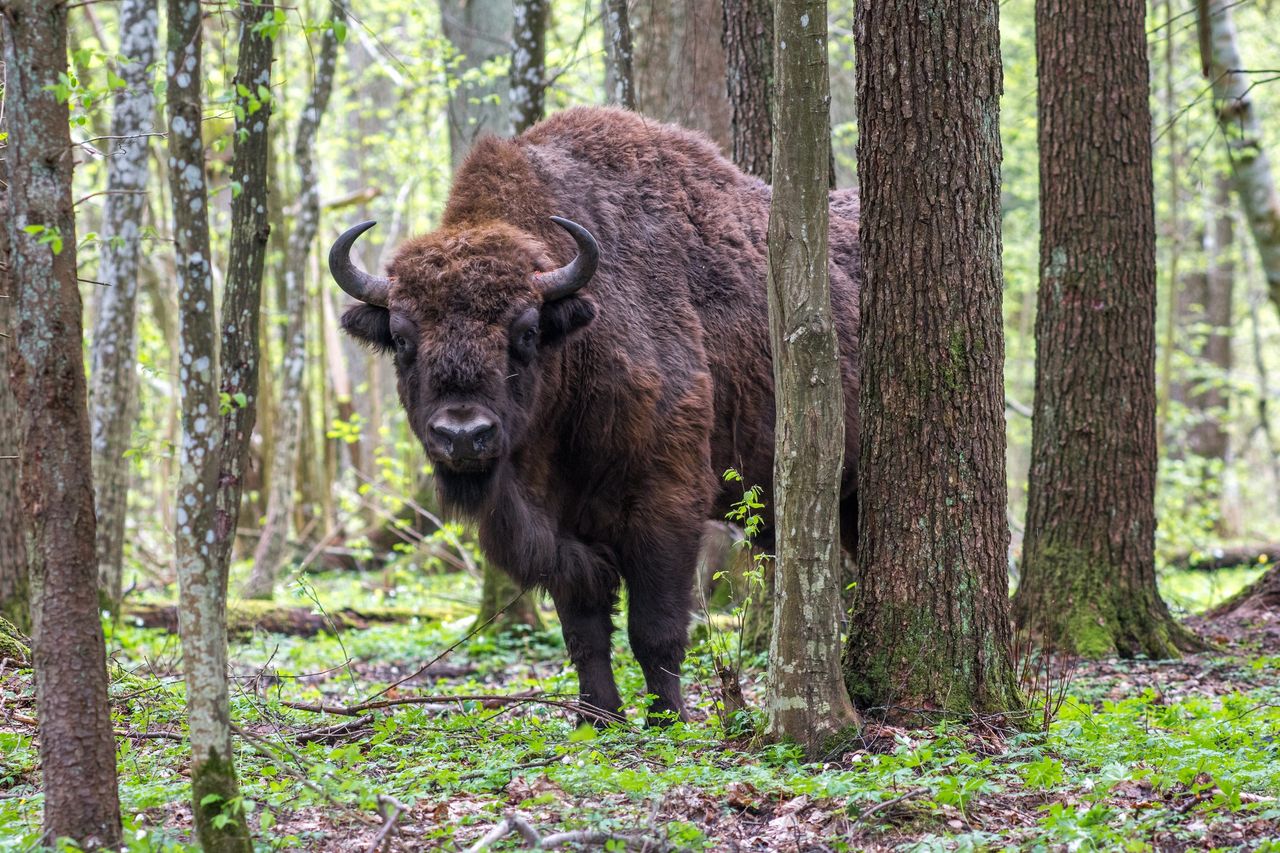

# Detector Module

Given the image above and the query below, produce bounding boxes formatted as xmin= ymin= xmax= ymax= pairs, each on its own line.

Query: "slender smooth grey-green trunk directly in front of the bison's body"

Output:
xmin=765 ymin=0 xmax=858 ymax=757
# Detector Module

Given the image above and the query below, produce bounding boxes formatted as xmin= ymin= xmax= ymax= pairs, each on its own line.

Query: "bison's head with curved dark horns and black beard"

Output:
xmin=329 ymin=216 xmax=599 ymax=510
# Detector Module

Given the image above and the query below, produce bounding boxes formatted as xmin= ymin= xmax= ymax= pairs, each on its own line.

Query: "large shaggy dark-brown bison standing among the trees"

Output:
xmin=329 ymin=108 xmax=859 ymax=722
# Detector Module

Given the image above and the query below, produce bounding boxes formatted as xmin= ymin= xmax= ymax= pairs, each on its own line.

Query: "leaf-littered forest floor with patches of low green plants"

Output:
xmin=0 ymin=563 xmax=1280 ymax=850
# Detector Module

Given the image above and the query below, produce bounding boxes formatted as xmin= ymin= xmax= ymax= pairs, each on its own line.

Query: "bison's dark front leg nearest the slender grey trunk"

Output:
xmin=622 ymin=517 xmax=701 ymax=725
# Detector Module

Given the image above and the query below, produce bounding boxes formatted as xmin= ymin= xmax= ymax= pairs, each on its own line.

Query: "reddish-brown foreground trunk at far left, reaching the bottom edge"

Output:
xmin=0 ymin=0 xmax=120 ymax=849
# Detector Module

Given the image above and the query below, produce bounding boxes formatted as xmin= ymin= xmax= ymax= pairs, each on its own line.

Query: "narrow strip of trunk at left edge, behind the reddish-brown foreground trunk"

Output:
xmin=0 ymin=48 xmax=31 ymax=631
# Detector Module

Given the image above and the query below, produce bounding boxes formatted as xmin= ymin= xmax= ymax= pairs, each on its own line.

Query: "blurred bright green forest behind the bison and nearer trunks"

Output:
xmin=0 ymin=0 xmax=1280 ymax=833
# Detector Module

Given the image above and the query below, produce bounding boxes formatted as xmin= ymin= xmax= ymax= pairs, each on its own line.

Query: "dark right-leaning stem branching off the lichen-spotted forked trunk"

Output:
xmin=214 ymin=0 xmax=275 ymax=576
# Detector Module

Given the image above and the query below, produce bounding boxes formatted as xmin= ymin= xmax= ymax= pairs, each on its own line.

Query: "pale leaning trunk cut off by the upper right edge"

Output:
xmin=1197 ymin=0 xmax=1280 ymax=311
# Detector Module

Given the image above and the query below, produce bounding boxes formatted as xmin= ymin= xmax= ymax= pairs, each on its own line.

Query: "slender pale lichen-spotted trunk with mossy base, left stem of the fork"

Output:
xmin=165 ymin=0 xmax=252 ymax=853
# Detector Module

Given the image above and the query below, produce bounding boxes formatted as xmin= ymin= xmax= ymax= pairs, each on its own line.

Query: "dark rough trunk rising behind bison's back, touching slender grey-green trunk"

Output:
xmin=721 ymin=0 xmax=773 ymax=181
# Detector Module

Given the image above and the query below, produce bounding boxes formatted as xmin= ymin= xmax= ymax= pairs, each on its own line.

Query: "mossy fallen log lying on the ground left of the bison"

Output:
xmin=123 ymin=601 xmax=422 ymax=637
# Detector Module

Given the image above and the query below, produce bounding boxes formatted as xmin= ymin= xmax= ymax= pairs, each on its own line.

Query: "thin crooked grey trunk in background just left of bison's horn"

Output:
xmin=243 ymin=3 xmax=344 ymax=598
